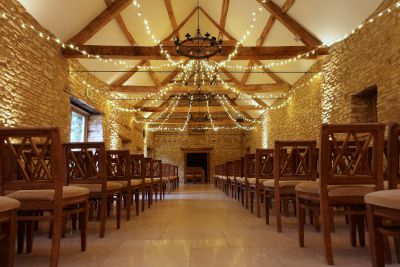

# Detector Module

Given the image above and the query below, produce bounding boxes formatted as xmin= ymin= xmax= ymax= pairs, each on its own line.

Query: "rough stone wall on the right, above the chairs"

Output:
xmin=246 ymin=0 xmax=400 ymax=149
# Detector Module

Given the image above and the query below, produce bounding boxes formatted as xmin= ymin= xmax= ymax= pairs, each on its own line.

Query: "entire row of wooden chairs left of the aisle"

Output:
xmin=0 ymin=128 xmax=179 ymax=266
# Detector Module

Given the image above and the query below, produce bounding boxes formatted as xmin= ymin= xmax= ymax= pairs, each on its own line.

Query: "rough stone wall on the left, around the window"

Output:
xmin=0 ymin=0 xmax=143 ymax=152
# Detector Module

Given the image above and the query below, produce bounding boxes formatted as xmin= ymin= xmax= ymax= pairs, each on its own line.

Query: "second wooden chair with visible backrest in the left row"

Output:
xmin=63 ymin=143 xmax=123 ymax=238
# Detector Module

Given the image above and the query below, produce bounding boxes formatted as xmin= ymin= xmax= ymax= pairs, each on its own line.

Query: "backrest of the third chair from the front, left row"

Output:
xmin=106 ymin=150 xmax=132 ymax=187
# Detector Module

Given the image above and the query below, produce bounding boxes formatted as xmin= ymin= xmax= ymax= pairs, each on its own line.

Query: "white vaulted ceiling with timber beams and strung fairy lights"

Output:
xmin=19 ymin=0 xmax=382 ymax=131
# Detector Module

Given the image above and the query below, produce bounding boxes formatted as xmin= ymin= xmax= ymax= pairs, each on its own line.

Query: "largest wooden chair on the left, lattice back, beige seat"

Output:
xmin=0 ymin=128 xmax=89 ymax=267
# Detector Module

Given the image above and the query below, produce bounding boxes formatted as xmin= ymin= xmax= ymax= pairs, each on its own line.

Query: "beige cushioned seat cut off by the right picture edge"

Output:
xmin=364 ymin=189 xmax=400 ymax=210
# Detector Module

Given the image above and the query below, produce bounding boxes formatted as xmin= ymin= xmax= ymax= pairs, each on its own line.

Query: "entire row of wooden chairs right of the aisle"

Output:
xmin=215 ymin=124 xmax=400 ymax=267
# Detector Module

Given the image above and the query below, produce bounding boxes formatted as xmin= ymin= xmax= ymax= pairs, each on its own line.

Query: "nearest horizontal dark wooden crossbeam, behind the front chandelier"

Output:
xmin=63 ymin=45 xmax=329 ymax=60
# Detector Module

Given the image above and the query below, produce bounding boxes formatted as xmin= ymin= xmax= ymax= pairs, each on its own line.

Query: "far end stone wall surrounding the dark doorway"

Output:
xmin=149 ymin=131 xmax=244 ymax=181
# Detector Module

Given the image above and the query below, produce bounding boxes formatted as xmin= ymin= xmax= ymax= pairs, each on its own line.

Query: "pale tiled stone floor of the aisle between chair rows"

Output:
xmin=15 ymin=185 xmax=400 ymax=267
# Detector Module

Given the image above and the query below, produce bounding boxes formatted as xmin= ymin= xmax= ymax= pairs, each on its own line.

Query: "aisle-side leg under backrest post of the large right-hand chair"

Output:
xmin=320 ymin=201 xmax=334 ymax=265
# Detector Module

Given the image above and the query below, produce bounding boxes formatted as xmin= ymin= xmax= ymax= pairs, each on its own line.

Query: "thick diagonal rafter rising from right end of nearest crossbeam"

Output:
xmin=257 ymin=0 xmax=322 ymax=47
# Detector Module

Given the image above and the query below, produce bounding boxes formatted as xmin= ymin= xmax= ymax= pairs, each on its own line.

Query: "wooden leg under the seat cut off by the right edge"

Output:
xmin=367 ymin=204 xmax=385 ymax=267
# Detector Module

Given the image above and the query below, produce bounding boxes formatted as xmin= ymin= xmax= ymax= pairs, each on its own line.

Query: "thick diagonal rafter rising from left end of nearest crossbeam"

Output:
xmin=67 ymin=0 xmax=133 ymax=45
